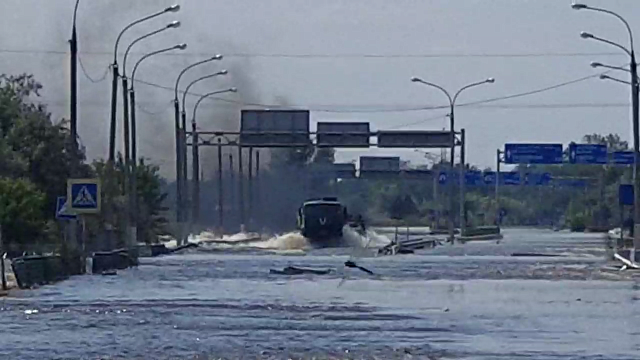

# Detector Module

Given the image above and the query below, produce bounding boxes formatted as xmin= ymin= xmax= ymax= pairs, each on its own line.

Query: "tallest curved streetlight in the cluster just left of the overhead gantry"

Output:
xmin=173 ymin=54 xmax=222 ymax=244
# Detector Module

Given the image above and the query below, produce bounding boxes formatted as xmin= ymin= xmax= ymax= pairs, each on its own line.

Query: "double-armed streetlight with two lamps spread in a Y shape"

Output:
xmin=411 ymin=77 xmax=495 ymax=244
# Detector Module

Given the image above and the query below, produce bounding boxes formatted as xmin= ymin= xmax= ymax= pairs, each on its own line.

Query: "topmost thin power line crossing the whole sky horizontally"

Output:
xmin=0 ymin=48 xmax=624 ymax=59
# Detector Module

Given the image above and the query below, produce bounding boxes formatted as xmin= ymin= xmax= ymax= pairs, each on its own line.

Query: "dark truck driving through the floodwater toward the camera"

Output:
xmin=297 ymin=197 xmax=358 ymax=245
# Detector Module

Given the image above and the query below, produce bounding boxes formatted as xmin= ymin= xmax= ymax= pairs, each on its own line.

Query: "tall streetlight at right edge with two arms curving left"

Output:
xmin=571 ymin=3 xmax=640 ymax=261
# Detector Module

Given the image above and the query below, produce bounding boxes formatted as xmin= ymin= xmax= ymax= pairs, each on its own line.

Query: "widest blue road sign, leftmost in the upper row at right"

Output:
xmin=504 ymin=144 xmax=562 ymax=164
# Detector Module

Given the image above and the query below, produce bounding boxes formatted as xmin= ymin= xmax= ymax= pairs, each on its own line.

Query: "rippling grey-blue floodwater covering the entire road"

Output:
xmin=0 ymin=229 xmax=640 ymax=360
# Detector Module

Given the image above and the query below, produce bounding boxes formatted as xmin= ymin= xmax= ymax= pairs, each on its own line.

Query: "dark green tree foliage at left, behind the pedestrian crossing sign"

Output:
xmin=0 ymin=74 xmax=164 ymax=249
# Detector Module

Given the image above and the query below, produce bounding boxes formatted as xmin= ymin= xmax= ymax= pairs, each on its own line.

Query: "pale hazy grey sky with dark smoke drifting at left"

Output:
xmin=0 ymin=0 xmax=640 ymax=177
